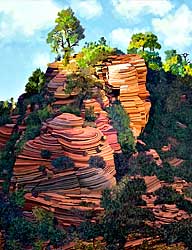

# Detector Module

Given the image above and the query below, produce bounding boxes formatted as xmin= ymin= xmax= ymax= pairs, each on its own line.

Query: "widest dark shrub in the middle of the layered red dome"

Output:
xmin=52 ymin=156 xmax=75 ymax=170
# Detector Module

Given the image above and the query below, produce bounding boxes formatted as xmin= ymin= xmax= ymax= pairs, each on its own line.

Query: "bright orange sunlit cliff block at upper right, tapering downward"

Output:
xmin=97 ymin=54 xmax=151 ymax=136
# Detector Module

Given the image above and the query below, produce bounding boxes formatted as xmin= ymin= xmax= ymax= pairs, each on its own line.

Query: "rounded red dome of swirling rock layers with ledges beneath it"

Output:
xmin=13 ymin=113 xmax=116 ymax=225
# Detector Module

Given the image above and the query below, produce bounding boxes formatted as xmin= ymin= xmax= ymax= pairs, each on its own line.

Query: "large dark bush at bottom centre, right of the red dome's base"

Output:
xmin=101 ymin=177 xmax=155 ymax=250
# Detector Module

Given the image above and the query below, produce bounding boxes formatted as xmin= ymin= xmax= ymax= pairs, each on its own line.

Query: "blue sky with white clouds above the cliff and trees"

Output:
xmin=0 ymin=0 xmax=192 ymax=100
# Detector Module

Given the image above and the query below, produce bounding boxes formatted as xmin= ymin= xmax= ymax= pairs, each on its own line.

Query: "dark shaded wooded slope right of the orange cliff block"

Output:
xmin=141 ymin=70 xmax=192 ymax=181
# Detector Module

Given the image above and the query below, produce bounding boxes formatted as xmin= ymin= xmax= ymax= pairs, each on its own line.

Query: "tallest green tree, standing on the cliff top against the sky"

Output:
xmin=47 ymin=8 xmax=85 ymax=64
